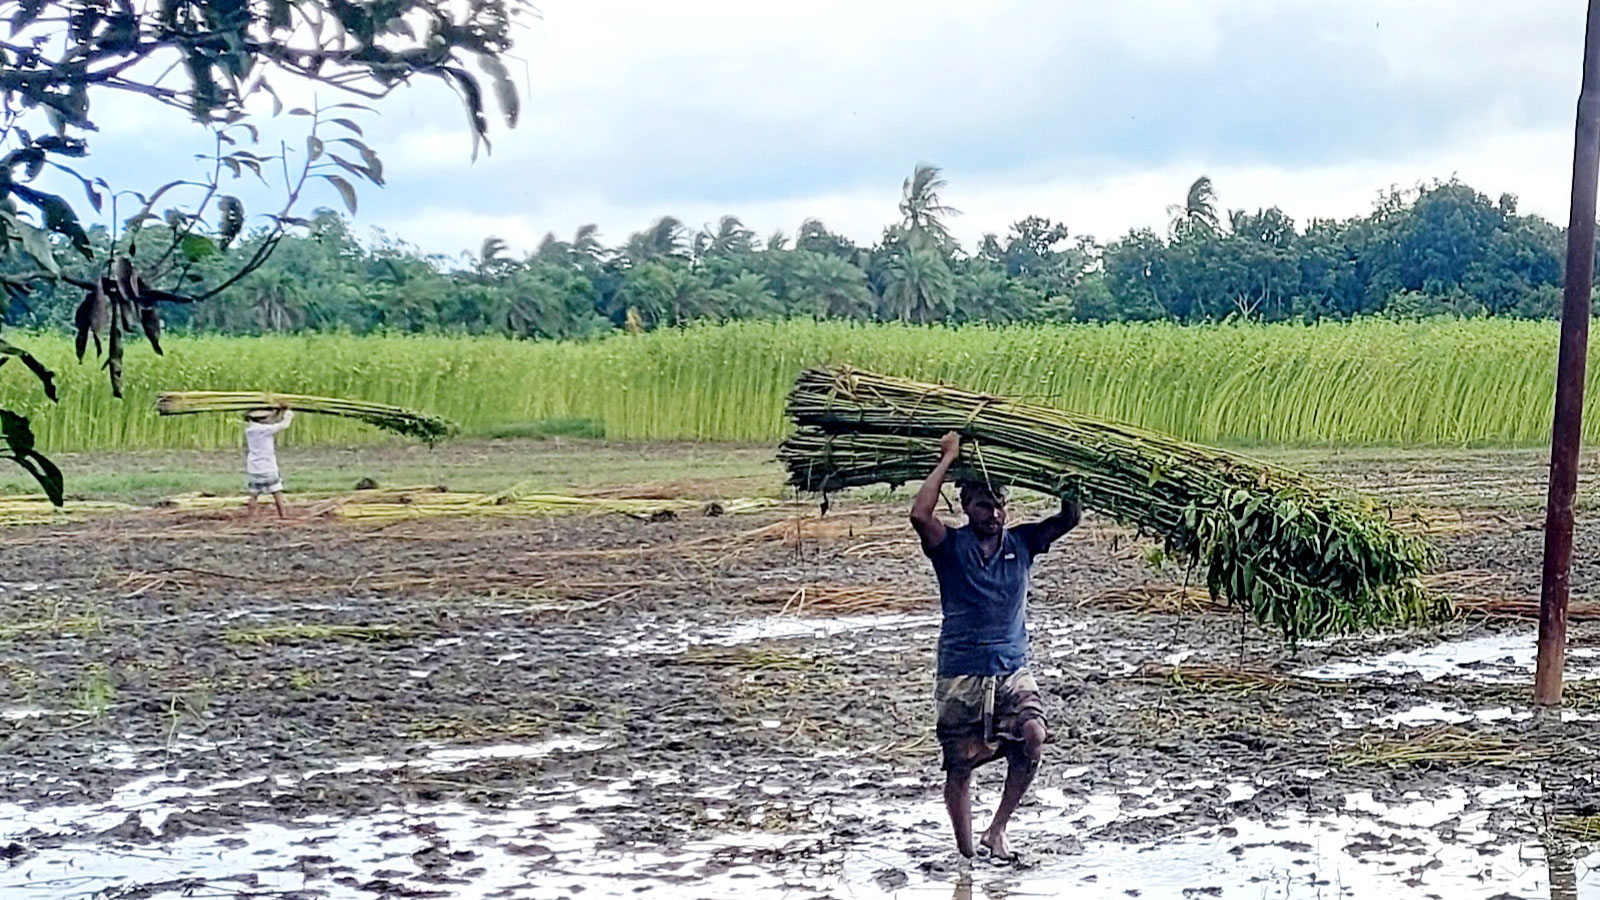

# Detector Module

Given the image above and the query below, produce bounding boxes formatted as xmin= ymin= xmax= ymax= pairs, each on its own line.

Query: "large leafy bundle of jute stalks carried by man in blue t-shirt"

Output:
xmin=779 ymin=360 xmax=1448 ymax=642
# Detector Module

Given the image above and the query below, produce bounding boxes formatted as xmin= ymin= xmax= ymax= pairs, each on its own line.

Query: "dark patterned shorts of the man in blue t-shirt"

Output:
xmin=933 ymin=669 xmax=1050 ymax=773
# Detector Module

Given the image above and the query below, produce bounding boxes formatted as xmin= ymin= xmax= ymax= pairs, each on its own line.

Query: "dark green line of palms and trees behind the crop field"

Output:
xmin=8 ymin=165 xmax=1565 ymax=338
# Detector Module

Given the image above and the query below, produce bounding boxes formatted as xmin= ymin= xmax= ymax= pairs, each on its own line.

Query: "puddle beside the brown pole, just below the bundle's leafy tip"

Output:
xmin=1298 ymin=631 xmax=1600 ymax=684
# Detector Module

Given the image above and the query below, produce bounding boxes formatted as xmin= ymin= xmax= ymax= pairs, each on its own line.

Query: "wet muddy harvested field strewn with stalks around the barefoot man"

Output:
xmin=0 ymin=445 xmax=1600 ymax=900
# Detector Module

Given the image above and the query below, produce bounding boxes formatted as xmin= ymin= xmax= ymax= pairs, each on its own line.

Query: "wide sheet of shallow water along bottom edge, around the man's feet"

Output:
xmin=0 ymin=762 xmax=1580 ymax=900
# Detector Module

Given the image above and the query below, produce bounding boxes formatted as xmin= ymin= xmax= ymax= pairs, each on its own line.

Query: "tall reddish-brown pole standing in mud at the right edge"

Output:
xmin=1533 ymin=0 xmax=1600 ymax=706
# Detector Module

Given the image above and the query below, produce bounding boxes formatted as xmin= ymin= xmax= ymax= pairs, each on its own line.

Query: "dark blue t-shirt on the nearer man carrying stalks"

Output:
xmin=925 ymin=525 xmax=1046 ymax=677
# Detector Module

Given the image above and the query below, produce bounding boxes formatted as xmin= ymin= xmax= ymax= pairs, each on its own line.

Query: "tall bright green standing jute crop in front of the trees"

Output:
xmin=0 ymin=319 xmax=1600 ymax=450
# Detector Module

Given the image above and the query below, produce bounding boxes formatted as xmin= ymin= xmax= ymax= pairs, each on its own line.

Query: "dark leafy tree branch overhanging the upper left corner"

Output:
xmin=0 ymin=0 xmax=530 ymax=496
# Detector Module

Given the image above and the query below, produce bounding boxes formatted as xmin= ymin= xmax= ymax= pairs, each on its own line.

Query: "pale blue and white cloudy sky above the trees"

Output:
xmin=68 ymin=0 xmax=1584 ymax=253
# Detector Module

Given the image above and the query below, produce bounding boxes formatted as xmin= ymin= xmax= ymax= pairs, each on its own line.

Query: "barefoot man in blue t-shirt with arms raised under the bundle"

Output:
xmin=910 ymin=432 xmax=1082 ymax=858
